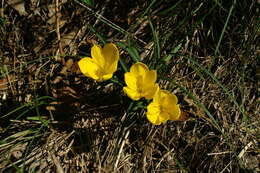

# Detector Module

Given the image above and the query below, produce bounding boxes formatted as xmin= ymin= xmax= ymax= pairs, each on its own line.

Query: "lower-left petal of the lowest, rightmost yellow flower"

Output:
xmin=146 ymin=102 xmax=161 ymax=125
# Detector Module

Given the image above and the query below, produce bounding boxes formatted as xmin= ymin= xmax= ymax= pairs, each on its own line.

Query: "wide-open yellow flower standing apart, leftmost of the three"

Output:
xmin=78 ymin=43 xmax=119 ymax=82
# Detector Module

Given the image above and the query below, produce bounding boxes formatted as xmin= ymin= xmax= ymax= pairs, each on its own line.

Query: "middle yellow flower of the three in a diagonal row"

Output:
xmin=123 ymin=62 xmax=158 ymax=100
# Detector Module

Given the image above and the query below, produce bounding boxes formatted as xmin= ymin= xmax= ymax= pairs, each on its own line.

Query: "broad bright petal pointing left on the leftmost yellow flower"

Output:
xmin=78 ymin=58 xmax=101 ymax=80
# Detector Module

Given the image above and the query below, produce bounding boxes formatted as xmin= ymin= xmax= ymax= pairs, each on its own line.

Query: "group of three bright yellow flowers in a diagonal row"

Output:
xmin=78 ymin=43 xmax=181 ymax=125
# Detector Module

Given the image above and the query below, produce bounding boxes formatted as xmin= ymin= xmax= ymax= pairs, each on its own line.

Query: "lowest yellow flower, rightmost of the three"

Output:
xmin=146 ymin=89 xmax=181 ymax=125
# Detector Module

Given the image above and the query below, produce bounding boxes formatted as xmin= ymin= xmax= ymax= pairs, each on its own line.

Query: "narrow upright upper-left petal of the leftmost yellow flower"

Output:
xmin=91 ymin=44 xmax=106 ymax=68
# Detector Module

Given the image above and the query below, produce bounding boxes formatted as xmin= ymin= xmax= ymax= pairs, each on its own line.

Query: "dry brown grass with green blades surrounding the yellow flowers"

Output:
xmin=0 ymin=0 xmax=260 ymax=172
